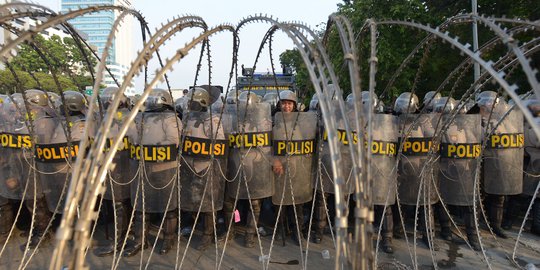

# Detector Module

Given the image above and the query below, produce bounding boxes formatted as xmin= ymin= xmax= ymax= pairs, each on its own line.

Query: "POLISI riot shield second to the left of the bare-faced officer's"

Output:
xmin=180 ymin=112 xmax=228 ymax=212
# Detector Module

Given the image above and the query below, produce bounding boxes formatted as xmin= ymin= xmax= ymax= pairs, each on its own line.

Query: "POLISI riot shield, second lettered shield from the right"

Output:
xmin=439 ymin=114 xmax=482 ymax=206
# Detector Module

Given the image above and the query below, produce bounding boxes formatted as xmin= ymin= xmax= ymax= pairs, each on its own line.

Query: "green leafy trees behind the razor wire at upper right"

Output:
xmin=280 ymin=0 xmax=540 ymax=104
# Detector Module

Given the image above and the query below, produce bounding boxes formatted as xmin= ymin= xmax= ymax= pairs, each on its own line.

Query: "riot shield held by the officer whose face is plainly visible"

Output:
xmin=272 ymin=112 xmax=317 ymax=205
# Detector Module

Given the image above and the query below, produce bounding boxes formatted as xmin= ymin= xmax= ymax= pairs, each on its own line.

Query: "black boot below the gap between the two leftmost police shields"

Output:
xmin=25 ymin=198 xmax=51 ymax=249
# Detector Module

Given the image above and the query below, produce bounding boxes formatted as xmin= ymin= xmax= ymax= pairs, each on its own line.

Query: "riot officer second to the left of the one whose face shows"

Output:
xmin=180 ymin=87 xmax=227 ymax=250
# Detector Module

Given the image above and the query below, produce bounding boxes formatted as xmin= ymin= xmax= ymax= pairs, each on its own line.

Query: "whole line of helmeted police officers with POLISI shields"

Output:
xmin=0 ymin=87 xmax=540 ymax=256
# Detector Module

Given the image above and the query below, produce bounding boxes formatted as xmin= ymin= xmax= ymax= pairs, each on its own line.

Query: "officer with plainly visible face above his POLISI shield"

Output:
xmin=272 ymin=90 xmax=317 ymax=245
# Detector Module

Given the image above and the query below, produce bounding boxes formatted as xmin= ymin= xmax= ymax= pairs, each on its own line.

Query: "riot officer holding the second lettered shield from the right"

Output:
xmin=434 ymin=97 xmax=482 ymax=250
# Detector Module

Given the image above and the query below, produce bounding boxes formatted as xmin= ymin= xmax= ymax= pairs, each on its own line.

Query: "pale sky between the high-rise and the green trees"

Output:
xmin=38 ymin=0 xmax=341 ymax=93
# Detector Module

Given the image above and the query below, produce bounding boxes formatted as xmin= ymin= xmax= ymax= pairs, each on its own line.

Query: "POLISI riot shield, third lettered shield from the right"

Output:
xmin=398 ymin=113 xmax=440 ymax=205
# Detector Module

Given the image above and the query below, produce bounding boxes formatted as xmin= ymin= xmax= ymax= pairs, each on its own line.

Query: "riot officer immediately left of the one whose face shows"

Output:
xmin=224 ymin=91 xmax=274 ymax=247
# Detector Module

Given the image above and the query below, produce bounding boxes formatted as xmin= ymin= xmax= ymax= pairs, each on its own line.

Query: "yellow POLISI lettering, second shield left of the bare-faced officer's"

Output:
xmin=182 ymin=136 xmax=228 ymax=158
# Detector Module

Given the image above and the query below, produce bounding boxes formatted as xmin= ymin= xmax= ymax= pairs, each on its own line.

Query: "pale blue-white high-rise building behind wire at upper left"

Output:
xmin=61 ymin=0 xmax=134 ymax=94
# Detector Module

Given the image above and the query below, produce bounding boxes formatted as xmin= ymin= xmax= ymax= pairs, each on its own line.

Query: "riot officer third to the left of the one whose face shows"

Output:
xmin=124 ymin=89 xmax=182 ymax=257
